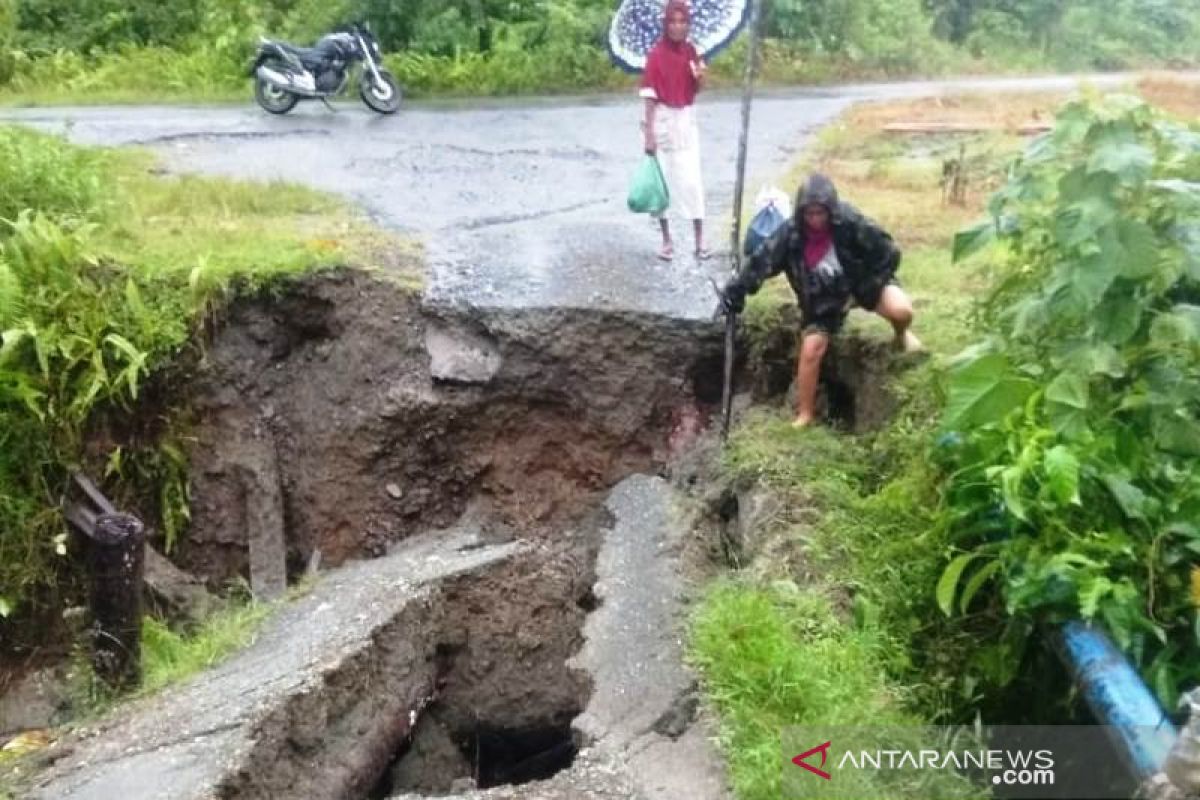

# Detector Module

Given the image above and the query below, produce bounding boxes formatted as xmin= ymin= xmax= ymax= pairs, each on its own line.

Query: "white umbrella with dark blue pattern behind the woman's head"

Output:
xmin=608 ymin=0 xmax=750 ymax=72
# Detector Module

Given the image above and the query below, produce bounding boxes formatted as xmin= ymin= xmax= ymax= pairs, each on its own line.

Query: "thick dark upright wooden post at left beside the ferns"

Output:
xmin=88 ymin=513 xmax=145 ymax=688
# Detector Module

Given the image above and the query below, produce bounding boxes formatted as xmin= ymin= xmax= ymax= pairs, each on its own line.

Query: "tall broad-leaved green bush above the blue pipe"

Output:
xmin=937 ymin=97 xmax=1200 ymax=708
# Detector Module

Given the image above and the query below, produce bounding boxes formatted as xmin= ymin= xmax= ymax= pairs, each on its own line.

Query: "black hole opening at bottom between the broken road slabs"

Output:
xmin=466 ymin=726 xmax=578 ymax=789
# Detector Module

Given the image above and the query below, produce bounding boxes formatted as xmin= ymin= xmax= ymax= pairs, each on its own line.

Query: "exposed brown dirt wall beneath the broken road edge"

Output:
xmin=181 ymin=271 xmax=720 ymax=583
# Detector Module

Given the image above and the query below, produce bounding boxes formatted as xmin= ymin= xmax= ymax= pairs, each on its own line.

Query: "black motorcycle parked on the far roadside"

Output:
xmin=250 ymin=25 xmax=401 ymax=114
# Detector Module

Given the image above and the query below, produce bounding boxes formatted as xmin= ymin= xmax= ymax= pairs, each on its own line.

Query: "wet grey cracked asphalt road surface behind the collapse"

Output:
xmin=0 ymin=74 xmax=1156 ymax=319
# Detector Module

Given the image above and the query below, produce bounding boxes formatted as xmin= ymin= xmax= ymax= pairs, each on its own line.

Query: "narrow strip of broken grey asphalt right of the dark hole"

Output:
xmin=574 ymin=475 xmax=730 ymax=800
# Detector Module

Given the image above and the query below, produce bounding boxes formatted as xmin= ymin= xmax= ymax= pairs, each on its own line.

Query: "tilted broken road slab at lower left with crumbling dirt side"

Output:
xmin=22 ymin=531 xmax=521 ymax=800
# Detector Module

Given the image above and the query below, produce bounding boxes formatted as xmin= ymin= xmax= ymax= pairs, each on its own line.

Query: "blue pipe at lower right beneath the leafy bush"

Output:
xmin=1057 ymin=621 xmax=1178 ymax=780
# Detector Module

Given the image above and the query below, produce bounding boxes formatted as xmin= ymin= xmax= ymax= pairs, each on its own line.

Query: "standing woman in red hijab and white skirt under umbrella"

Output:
xmin=638 ymin=0 xmax=708 ymax=261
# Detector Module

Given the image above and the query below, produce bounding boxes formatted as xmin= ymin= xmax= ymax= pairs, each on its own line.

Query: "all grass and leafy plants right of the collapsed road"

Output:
xmin=692 ymin=79 xmax=1200 ymax=800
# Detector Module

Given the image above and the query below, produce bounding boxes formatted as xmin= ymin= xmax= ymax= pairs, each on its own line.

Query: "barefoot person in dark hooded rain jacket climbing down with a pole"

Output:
xmin=722 ymin=174 xmax=920 ymax=427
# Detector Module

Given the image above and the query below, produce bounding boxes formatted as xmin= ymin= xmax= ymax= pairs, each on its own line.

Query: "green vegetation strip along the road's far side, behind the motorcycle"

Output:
xmin=0 ymin=0 xmax=1200 ymax=104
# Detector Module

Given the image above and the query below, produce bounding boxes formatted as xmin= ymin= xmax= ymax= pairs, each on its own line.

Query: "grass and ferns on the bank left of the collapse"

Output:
xmin=0 ymin=127 xmax=408 ymax=623
